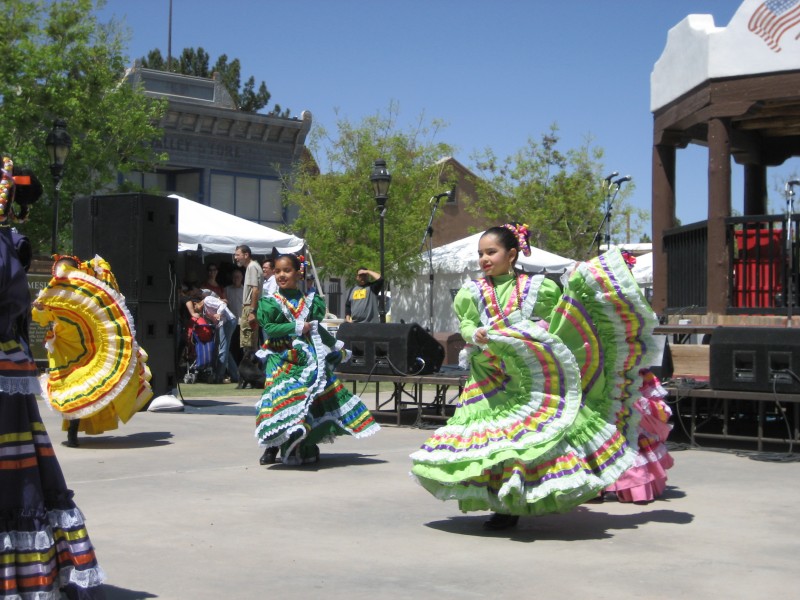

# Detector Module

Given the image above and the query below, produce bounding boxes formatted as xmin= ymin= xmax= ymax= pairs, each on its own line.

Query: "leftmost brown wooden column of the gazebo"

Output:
xmin=651 ymin=144 xmax=675 ymax=314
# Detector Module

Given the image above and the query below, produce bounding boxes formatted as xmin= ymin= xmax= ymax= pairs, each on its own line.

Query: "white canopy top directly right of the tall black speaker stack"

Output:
xmin=170 ymin=194 xmax=305 ymax=255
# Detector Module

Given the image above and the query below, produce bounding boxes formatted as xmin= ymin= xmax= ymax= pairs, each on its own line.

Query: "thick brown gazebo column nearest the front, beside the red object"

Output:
xmin=706 ymin=118 xmax=731 ymax=315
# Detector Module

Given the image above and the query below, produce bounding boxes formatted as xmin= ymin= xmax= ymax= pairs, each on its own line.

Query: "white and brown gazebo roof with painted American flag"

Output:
xmin=650 ymin=0 xmax=800 ymax=166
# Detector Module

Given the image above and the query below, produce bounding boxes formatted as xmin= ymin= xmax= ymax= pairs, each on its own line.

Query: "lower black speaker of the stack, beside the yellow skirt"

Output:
xmin=125 ymin=302 xmax=178 ymax=396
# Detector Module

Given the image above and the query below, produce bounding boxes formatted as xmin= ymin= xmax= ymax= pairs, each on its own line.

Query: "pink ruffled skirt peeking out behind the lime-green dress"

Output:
xmin=606 ymin=369 xmax=674 ymax=502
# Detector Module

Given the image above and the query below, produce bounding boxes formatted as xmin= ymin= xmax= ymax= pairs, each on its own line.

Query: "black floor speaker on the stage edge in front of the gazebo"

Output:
xmin=709 ymin=327 xmax=800 ymax=394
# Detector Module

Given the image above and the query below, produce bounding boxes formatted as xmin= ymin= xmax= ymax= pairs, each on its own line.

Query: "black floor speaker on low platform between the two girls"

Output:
xmin=336 ymin=323 xmax=444 ymax=375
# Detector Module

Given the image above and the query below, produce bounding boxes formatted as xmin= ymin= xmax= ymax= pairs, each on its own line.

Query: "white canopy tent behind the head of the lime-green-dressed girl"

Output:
xmin=391 ymin=233 xmax=575 ymax=333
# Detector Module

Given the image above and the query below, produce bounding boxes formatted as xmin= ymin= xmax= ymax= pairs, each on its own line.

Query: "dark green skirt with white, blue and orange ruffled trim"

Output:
xmin=256 ymin=330 xmax=380 ymax=458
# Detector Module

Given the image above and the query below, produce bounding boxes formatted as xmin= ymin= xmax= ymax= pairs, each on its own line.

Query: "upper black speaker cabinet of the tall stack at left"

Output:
xmin=72 ymin=194 xmax=177 ymax=302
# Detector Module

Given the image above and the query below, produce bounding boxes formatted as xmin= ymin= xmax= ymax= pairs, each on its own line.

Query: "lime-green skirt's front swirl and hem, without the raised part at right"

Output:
xmin=411 ymin=302 xmax=633 ymax=515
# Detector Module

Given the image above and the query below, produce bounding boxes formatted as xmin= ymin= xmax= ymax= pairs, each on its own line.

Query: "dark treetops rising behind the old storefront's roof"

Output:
xmin=140 ymin=47 xmax=290 ymax=117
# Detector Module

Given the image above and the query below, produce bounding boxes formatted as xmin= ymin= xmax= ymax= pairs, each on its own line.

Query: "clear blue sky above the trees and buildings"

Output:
xmin=99 ymin=0 xmax=800 ymax=232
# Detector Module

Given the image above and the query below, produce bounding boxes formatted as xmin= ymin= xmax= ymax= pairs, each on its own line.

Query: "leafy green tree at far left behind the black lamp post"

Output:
xmin=0 ymin=0 xmax=165 ymax=252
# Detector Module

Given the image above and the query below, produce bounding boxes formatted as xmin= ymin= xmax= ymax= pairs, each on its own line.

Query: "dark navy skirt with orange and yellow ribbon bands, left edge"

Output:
xmin=0 ymin=341 xmax=105 ymax=600
